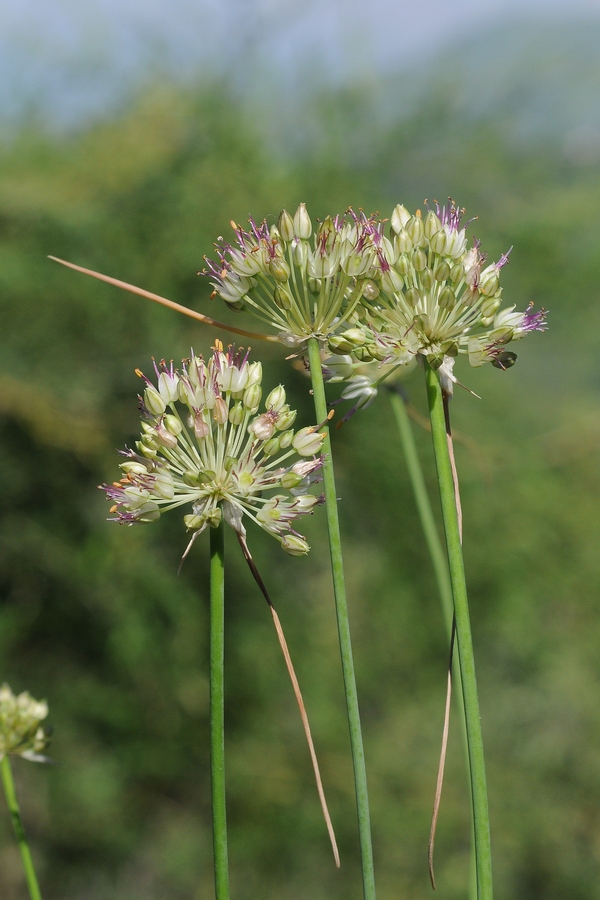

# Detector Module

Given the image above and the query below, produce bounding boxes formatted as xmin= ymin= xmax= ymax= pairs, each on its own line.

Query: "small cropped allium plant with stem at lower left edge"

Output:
xmin=0 ymin=684 xmax=50 ymax=900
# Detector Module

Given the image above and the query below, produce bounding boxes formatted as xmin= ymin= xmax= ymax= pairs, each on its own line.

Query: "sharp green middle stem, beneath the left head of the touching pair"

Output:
xmin=308 ymin=338 xmax=375 ymax=900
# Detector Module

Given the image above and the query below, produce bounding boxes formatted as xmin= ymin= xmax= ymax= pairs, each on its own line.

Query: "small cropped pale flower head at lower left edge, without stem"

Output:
xmin=0 ymin=684 xmax=48 ymax=762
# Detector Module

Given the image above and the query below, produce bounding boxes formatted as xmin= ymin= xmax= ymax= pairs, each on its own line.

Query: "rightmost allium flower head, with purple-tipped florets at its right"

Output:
xmin=329 ymin=202 xmax=545 ymax=368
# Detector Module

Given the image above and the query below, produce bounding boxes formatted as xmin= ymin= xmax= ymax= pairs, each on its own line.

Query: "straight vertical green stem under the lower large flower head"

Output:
xmin=210 ymin=522 xmax=229 ymax=900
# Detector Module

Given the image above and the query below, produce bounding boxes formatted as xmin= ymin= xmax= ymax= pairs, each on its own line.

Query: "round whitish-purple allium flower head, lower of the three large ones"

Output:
xmin=102 ymin=341 xmax=325 ymax=556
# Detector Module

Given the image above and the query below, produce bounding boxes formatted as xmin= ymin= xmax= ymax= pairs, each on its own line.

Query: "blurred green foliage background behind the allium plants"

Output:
xmin=0 ymin=84 xmax=600 ymax=900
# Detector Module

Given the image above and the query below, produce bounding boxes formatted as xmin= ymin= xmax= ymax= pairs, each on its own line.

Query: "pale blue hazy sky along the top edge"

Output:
xmin=0 ymin=0 xmax=600 ymax=126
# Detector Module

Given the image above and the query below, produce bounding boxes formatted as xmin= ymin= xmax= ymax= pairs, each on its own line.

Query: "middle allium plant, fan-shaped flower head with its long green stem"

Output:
xmin=204 ymin=203 xmax=378 ymax=900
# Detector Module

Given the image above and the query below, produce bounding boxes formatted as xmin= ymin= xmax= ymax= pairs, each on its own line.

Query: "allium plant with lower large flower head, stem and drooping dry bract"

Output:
xmin=102 ymin=341 xmax=339 ymax=900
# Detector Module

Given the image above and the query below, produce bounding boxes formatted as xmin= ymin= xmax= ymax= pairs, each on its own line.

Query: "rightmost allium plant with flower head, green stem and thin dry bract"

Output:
xmin=325 ymin=202 xmax=545 ymax=900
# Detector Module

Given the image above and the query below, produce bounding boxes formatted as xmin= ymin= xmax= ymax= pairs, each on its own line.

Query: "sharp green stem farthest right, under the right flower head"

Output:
xmin=425 ymin=362 xmax=493 ymax=900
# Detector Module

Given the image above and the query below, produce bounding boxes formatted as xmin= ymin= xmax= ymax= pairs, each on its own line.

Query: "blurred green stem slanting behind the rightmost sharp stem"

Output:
xmin=389 ymin=388 xmax=477 ymax=898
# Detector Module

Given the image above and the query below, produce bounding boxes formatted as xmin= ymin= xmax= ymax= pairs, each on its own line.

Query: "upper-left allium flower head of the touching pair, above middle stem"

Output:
xmin=205 ymin=203 xmax=386 ymax=347
